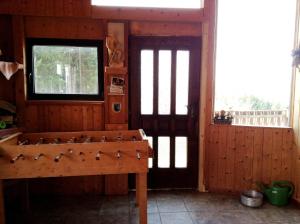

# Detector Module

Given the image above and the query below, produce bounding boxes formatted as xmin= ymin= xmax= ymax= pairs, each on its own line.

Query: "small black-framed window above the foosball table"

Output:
xmin=26 ymin=39 xmax=103 ymax=100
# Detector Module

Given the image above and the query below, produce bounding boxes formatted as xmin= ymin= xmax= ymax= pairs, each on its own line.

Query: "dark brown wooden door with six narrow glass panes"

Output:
xmin=129 ymin=37 xmax=201 ymax=188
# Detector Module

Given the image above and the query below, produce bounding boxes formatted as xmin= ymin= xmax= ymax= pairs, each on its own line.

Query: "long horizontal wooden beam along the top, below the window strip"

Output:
xmin=0 ymin=0 xmax=205 ymax=23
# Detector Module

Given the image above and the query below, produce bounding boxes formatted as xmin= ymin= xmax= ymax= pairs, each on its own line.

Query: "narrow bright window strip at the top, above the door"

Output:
xmin=92 ymin=0 xmax=203 ymax=9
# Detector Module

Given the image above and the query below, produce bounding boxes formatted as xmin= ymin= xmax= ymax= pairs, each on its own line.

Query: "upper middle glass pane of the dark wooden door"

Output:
xmin=158 ymin=50 xmax=171 ymax=114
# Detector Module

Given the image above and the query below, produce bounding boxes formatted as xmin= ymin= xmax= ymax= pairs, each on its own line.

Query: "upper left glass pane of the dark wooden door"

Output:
xmin=141 ymin=50 xmax=153 ymax=114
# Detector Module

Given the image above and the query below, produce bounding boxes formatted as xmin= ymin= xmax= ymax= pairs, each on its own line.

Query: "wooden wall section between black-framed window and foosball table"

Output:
xmin=25 ymin=103 xmax=104 ymax=132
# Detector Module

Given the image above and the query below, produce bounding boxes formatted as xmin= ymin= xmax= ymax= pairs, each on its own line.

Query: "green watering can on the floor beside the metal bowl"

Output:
xmin=258 ymin=181 xmax=294 ymax=206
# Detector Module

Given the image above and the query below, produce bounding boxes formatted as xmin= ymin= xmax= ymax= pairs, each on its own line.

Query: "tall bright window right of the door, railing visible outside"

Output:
xmin=214 ymin=0 xmax=296 ymax=126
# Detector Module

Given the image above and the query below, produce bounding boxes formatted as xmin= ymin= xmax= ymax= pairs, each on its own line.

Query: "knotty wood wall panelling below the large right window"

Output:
xmin=206 ymin=125 xmax=295 ymax=192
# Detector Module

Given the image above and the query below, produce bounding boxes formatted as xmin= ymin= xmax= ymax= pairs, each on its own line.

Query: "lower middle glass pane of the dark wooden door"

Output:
xmin=158 ymin=137 xmax=170 ymax=168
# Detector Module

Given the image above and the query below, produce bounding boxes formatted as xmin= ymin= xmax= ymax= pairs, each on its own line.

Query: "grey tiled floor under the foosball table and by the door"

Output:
xmin=5 ymin=191 xmax=300 ymax=224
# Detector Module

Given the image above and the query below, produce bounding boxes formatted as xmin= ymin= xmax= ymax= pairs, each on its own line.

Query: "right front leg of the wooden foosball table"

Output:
xmin=136 ymin=173 xmax=147 ymax=224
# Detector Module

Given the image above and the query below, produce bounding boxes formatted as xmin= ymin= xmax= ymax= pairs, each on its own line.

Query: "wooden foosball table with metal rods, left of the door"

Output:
xmin=0 ymin=130 xmax=151 ymax=224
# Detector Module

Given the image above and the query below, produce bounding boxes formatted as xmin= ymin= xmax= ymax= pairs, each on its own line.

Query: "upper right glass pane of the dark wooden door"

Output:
xmin=176 ymin=51 xmax=190 ymax=114
